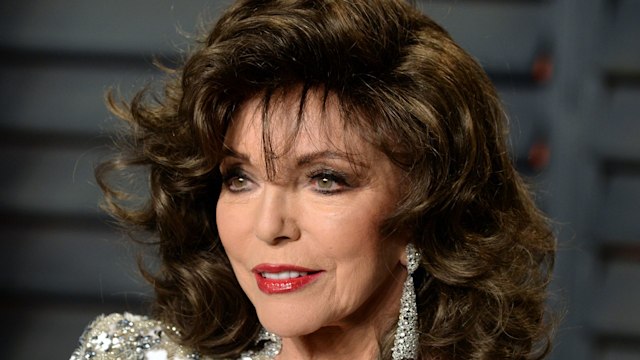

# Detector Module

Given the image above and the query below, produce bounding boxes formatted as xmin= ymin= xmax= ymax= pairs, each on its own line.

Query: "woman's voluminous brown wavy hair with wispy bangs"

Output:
xmin=97 ymin=0 xmax=555 ymax=359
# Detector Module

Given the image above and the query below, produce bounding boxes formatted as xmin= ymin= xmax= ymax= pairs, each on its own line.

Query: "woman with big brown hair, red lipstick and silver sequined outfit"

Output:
xmin=72 ymin=0 xmax=554 ymax=360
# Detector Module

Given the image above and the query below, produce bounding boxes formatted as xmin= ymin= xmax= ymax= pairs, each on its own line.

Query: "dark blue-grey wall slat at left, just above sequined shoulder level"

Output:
xmin=0 ymin=221 xmax=154 ymax=301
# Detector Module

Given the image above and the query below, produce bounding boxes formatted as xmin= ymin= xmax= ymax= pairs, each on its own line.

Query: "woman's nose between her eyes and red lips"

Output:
xmin=255 ymin=185 xmax=300 ymax=245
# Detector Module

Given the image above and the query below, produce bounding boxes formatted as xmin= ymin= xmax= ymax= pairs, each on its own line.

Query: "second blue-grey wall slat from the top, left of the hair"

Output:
xmin=0 ymin=60 xmax=157 ymax=135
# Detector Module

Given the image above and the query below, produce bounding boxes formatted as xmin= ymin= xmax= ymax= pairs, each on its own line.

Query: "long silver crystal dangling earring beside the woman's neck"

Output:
xmin=391 ymin=244 xmax=420 ymax=360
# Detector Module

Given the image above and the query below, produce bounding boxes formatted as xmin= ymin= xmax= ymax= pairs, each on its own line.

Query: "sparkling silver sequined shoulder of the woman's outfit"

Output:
xmin=70 ymin=313 xmax=208 ymax=360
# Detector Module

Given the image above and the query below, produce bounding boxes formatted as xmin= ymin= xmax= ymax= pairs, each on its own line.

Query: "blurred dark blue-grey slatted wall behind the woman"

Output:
xmin=0 ymin=0 xmax=640 ymax=360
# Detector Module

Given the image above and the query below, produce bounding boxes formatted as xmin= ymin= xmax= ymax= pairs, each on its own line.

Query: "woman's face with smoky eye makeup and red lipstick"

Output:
xmin=216 ymin=93 xmax=407 ymax=337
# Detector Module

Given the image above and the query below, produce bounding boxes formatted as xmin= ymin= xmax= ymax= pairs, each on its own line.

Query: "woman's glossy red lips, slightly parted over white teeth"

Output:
xmin=252 ymin=264 xmax=322 ymax=294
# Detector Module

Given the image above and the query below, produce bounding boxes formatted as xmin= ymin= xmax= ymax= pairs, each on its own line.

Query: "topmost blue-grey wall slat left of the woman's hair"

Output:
xmin=0 ymin=0 xmax=229 ymax=54
